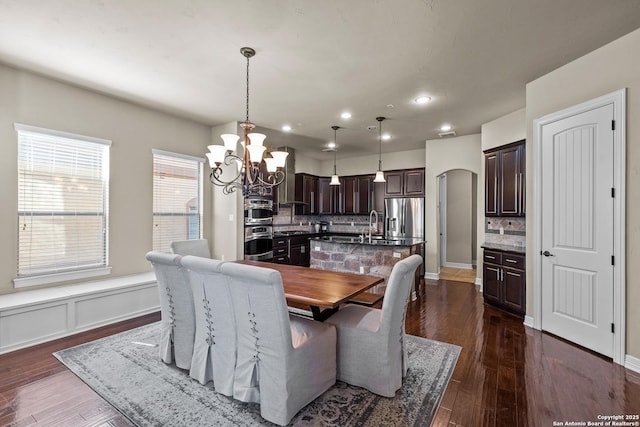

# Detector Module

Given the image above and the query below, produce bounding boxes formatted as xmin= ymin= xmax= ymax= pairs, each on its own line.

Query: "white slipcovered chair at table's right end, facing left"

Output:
xmin=326 ymin=255 xmax=422 ymax=397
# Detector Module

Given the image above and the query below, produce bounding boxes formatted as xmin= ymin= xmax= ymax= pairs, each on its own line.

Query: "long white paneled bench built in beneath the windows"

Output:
xmin=0 ymin=273 xmax=160 ymax=354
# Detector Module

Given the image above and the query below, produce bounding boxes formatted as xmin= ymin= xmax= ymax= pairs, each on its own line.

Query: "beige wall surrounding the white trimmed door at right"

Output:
xmin=526 ymin=30 xmax=640 ymax=358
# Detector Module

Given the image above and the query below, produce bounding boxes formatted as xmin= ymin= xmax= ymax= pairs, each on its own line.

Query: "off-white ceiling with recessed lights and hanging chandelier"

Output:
xmin=0 ymin=0 xmax=640 ymax=159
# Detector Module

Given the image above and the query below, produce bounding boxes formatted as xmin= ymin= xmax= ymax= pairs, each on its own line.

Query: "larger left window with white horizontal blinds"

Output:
xmin=14 ymin=124 xmax=111 ymax=287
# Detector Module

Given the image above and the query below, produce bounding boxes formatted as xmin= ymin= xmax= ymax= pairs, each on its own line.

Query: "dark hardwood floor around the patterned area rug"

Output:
xmin=0 ymin=280 xmax=640 ymax=426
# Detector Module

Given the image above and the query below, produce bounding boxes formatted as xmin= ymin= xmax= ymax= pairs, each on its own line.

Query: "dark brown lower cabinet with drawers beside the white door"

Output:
xmin=482 ymin=249 xmax=526 ymax=316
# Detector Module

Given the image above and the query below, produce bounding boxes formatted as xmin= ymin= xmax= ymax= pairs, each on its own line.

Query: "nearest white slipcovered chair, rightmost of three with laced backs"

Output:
xmin=221 ymin=263 xmax=336 ymax=425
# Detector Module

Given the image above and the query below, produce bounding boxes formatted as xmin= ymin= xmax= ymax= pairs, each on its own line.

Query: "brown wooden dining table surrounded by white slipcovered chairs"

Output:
xmin=236 ymin=260 xmax=384 ymax=321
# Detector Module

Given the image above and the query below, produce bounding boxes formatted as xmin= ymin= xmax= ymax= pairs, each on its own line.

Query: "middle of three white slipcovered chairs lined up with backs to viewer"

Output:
xmin=182 ymin=256 xmax=236 ymax=396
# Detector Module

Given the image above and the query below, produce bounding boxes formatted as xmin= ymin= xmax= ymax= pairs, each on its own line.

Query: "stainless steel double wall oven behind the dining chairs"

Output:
xmin=244 ymin=198 xmax=273 ymax=261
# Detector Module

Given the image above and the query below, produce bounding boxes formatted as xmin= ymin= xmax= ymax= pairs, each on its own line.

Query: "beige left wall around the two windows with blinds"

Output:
xmin=0 ymin=65 xmax=211 ymax=294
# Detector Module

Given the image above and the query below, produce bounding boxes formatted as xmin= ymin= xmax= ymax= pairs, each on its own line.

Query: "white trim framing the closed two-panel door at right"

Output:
xmin=533 ymin=88 xmax=627 ymax=365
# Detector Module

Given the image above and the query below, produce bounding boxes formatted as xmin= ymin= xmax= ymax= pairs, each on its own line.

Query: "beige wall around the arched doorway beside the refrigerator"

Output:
xmin=425 ymin=134 xmax=484 ymax=277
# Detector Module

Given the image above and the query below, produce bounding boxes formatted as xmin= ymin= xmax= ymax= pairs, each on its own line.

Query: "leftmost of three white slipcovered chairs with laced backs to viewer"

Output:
xmin=146 ymin=251 xmax=195 ymax=369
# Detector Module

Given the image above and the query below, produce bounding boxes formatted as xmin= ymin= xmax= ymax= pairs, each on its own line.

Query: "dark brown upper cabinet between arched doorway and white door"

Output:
xmin=484 ymin=140 xmax=526 ymax=216
